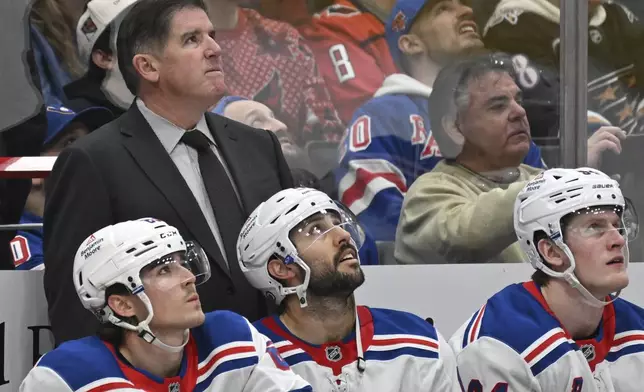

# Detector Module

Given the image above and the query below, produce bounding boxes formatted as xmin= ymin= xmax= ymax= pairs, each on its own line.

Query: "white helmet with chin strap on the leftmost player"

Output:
xmin=74 ymin=218 xmax=210 ymax=352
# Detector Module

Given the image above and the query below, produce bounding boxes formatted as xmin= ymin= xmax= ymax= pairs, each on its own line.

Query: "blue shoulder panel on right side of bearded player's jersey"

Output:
xmin=369 ymin=308 xmax=438 ymax=341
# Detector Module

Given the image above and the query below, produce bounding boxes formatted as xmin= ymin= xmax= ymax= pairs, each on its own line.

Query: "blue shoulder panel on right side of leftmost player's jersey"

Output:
xmin=191 ymin=310 xmax=253 ymax=350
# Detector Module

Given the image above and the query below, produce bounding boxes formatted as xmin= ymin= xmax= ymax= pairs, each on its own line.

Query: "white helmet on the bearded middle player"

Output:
xmin=237 ymin=188 xmax=364 ymax=307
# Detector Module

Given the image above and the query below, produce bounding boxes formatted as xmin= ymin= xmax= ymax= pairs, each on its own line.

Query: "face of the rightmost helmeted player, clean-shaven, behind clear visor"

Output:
xmin=566 ymin=210 xmax=628 ymax=298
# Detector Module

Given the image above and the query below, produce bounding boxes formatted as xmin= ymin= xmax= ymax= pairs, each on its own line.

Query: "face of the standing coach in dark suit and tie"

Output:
xmin=158 ymin=8 xmax=226 ymax=105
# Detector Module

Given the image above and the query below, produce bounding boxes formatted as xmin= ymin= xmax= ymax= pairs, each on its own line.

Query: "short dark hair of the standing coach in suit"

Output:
xmin=116 ymin=0 xmax=207 ymax=96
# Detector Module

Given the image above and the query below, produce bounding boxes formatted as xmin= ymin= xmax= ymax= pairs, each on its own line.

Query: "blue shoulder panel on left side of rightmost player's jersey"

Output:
xmin=461 ymin=283 xmax=563 ymax=354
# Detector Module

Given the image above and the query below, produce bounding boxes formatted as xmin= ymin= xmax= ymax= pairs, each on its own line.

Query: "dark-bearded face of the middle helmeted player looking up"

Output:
xmin=291 ymin=213 xmax=364 ymax=297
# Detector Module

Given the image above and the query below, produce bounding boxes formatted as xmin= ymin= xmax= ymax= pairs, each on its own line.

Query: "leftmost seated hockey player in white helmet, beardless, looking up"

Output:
xmin=20 ymin=218 xmax=311 ymax=392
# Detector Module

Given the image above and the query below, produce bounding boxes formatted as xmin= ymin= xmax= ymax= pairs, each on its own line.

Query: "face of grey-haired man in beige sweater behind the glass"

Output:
xmin=457 ymin=72 xmax=530 ymax=167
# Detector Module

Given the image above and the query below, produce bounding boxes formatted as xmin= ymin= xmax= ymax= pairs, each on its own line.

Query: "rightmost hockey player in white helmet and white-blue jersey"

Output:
xmin=450 ymin=168 xmax=644 ymax=392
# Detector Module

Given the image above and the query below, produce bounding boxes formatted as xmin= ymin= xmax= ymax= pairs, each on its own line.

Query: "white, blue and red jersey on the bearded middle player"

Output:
xmin=255 ymin=306 xmax=459 ymax=392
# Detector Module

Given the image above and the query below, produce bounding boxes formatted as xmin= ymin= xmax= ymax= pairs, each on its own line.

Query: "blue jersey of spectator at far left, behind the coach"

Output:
xmin=9 ymin=212 xmax=45 ymax=270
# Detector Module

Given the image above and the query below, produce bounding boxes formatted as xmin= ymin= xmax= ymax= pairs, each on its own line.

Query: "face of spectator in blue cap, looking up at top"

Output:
xmin=410 ymin=0 xmax=483 ymax=64
